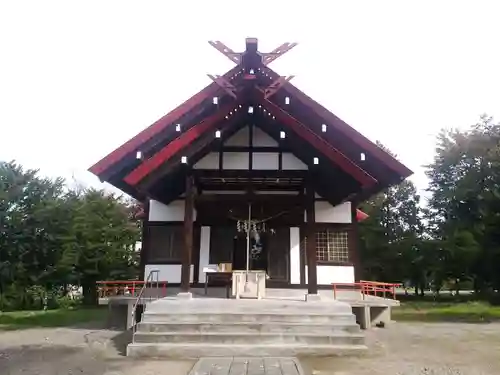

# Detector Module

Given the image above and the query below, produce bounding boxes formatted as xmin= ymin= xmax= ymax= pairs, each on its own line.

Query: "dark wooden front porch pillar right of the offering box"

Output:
xmin=305 ymin=181 xmax=318 ymax=294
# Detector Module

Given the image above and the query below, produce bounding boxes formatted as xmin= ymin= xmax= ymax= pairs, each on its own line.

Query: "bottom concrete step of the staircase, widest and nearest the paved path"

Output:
xmin=127 ymin=343 xmax=367 ymax=359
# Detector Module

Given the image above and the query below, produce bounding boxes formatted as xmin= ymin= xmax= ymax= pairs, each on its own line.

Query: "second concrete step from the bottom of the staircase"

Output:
xmin=137 ymin=322 xmax=360 ymax=335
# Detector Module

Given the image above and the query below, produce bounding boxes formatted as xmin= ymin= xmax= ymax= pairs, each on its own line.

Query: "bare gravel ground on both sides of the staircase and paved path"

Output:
xmin=0 ymin=323 xmax=500 ymax=375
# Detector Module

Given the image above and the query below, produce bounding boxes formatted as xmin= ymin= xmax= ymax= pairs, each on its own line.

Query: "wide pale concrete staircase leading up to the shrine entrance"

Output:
xmin=127 ymin=299 xmax=366 ymax=358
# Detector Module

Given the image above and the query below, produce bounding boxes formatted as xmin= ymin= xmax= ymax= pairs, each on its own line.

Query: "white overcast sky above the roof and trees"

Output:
xmin=0 ymin=0 xmax=500 ymax=200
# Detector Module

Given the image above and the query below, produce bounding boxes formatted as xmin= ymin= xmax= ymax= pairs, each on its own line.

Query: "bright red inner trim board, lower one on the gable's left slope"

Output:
xmin=124 ymin=102 xmax=237 ymax=186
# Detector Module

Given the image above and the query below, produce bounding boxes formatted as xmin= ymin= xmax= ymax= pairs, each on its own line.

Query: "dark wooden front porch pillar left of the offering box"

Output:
xmin=181 ymin=174 xmax=195 ymax=293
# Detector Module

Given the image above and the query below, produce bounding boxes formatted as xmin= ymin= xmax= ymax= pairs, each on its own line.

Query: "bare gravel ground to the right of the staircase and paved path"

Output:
xmin=302 ymin=323 xmax=500 ymax=375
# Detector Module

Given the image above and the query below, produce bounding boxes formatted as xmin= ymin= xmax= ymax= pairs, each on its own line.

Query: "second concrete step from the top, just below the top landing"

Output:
xmin=142 ymin=311 xmax=356 ymax=324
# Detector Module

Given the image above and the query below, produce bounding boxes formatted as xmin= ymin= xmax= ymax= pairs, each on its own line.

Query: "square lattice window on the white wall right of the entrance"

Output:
xmin=301 ymin=230 xmax=349 ymax=263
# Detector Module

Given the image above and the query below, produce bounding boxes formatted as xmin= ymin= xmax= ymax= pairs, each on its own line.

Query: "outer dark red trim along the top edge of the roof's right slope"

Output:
xmin=268 ymin=68 xmax=413 ymax=178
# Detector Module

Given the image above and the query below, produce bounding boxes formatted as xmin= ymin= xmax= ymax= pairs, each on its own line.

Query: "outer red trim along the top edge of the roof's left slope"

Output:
xmin=89 ymin=66 xmax=241 ymax=175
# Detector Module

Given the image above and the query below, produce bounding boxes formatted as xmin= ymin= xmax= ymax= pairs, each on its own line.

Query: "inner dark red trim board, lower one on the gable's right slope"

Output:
xmin=261 ymin=98 xmax=377 ymax=187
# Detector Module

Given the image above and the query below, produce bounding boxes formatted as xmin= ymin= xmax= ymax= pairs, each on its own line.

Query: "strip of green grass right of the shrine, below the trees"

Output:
xmin=392 ymin=301 xmax=500 ymax=323
